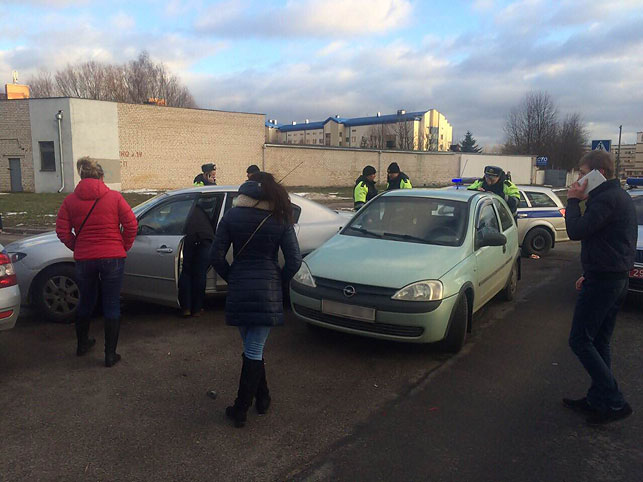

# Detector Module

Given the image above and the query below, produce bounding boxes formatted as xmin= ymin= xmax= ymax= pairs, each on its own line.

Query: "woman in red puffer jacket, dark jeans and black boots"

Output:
xmin=56 ymin=157 xmax=138 ymax=367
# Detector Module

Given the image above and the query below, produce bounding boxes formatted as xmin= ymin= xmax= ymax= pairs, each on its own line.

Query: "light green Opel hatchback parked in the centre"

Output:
xmin=290 ymin=189 xmax=520 ymax=352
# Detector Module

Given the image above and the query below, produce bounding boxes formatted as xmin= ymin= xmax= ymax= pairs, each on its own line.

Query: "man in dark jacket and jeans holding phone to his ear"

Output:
xmin=563 ymin=151 xmax=637 ymax=425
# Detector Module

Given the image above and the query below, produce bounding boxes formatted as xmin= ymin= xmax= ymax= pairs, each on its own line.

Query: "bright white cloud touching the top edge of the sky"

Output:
xmin=196 ymin=0 xmax=413 ymax=37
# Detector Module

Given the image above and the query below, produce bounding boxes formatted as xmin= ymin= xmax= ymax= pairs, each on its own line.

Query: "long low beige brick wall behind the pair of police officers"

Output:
xmin=260 ymin=145 xmax=460 ymax=187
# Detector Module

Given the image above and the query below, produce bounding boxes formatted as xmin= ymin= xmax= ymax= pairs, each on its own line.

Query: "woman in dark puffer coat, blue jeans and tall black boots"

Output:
xmin=212 ymin=172 xmax=301 ymax=427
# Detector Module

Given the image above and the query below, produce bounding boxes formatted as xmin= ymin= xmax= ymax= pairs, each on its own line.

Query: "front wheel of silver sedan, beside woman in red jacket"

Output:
xmin=32 ymin=264 xmax=80 ymax=323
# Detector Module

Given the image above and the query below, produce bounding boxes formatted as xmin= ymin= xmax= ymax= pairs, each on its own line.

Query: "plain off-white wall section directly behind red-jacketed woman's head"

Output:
xmin=65 ymin=99 xmax=121 ymax=190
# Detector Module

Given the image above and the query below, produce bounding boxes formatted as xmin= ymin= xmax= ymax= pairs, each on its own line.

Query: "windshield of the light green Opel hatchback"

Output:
xmin=342 ymin=196 xmax=468 ymax=246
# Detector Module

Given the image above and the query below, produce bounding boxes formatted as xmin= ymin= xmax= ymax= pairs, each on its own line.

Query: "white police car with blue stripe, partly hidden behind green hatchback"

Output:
xmin=450 ymin=178 xmax=569 ymax=256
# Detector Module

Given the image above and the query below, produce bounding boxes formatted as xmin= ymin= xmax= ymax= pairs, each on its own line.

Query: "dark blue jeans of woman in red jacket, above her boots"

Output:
xmin=76 ymin=258 xmax=125 ymax=320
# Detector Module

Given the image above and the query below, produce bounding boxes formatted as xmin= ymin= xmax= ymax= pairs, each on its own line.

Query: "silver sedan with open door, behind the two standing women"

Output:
xmin=7 ymin=186 xmax=350 ymax=322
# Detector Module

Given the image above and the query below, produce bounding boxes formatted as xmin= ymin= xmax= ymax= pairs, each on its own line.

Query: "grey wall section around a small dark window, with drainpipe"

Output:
xmin=29 ymin=98 xmax=76 ymax=192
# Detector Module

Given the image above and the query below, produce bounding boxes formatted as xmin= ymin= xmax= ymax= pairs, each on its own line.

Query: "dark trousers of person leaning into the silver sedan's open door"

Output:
xmin=179 ymin=239 xmax=212 ymax=314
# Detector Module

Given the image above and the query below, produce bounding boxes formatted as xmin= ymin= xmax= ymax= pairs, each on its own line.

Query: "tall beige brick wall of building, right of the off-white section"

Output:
xmin=118 ymin=104 xmax=265 ymax=189
